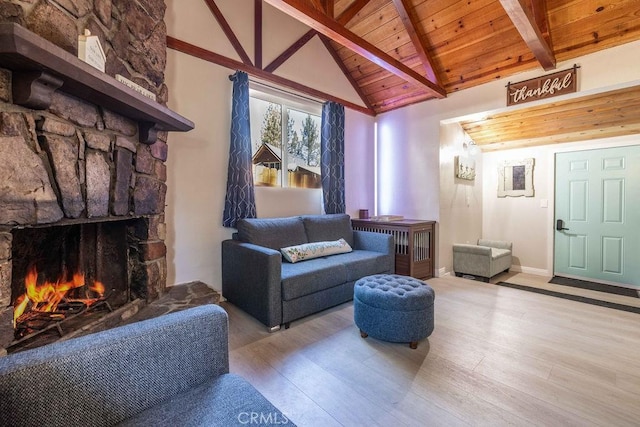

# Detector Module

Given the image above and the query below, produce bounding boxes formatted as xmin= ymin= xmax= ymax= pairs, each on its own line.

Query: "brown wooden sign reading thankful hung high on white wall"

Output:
xmin=507 ymin=65 xmax=578 ymax=107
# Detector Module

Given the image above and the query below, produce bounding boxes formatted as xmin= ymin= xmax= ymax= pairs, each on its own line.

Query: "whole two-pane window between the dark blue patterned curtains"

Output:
xmin=249 ymin=86 xmax=322 ymax=188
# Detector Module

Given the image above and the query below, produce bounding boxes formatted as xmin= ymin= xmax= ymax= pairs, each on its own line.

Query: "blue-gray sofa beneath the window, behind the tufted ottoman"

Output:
xmin=222 ymin=214 xmax=395 ymax=331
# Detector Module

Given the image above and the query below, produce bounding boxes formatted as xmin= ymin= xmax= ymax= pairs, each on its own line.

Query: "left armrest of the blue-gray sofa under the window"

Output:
xmin=222 ymin=240 xmax=282 ymax=328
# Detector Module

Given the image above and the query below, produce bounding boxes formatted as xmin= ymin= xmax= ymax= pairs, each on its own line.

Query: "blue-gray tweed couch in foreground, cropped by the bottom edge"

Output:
xmin=0 ymin=305 xmax=294 ymax=427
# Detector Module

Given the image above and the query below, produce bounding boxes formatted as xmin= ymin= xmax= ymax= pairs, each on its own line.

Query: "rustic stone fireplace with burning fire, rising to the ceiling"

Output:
xmin=0 ymin=0 xmax=193 ymax=354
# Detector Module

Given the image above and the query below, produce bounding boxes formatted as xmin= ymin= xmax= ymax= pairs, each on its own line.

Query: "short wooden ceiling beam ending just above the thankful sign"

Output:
xmin=500 ymin=0 xmax=556 ymax=71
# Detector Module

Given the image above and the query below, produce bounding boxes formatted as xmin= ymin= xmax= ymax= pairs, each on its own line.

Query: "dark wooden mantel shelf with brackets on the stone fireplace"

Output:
xmin=0 ymin=23 xmax=194 ymax=144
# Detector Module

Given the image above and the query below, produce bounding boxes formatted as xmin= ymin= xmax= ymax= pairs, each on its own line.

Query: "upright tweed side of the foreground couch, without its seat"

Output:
xmin=0 ymin=305 xmax=229 ymax=426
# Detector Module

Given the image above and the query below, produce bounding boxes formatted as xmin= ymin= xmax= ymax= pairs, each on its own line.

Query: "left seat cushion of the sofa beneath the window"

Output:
xmin=281 ymin=255 xmax=347 ymax=301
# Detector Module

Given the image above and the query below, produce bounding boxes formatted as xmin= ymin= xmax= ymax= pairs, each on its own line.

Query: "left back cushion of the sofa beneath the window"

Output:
xmin=237 ymin=217 xmax=308 ymax=251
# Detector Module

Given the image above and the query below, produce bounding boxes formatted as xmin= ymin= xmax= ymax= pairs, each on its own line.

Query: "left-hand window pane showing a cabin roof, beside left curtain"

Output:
xmin=249 ymin=98 xmax=282 ymax=187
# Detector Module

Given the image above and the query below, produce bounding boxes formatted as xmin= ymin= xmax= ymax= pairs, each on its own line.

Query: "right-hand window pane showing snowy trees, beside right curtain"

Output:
xmin=287 ymin=108 xmax=322 ymax=188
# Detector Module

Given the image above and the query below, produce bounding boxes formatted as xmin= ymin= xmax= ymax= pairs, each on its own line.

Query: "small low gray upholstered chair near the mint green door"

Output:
xmin=453 ymin=239 xmax=512 ymax=282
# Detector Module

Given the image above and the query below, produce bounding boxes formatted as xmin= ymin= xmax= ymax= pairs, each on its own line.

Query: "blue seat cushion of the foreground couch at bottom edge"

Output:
xmin=118 ymin=374 xmax=294 ymax=426
